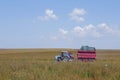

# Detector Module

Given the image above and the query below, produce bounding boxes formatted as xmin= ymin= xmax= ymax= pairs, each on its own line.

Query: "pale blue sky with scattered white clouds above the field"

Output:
xmin=0 ymin=0 xmax=120 ymax=49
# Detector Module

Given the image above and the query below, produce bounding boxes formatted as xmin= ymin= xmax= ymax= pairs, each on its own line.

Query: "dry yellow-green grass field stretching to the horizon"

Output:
xmin=0 ymin=49 xmax=120 ymax=80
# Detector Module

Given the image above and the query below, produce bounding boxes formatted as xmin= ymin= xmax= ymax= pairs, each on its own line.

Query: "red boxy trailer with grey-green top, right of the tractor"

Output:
xmin=77 ymin=46 xmax=96 ymax=61
